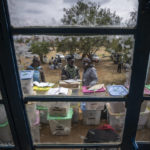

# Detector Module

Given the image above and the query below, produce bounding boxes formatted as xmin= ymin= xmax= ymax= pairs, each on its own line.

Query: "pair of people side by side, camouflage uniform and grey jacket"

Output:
xmin=61 ymin=55 xmax=98 ymax=87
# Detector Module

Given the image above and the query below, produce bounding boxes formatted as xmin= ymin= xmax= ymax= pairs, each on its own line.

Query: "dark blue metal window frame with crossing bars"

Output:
xmin=0 ymin=0 xmax=150 ymax=150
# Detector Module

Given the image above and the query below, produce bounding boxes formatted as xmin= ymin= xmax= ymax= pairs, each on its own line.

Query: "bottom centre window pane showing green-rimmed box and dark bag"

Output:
xmin=26 ymin=102 xmax=126 ymax=144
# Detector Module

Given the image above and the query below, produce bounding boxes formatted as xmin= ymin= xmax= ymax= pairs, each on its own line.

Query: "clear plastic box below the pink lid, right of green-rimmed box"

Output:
xmin=81 ymin=102 xmax=104 ymax=125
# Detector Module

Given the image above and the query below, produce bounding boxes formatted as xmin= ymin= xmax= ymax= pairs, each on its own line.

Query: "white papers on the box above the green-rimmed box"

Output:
xmin=47 ymin=87 xmax=69 ymax=95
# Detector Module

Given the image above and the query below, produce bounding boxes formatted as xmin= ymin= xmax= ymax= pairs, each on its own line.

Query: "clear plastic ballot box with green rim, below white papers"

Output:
xmin=47 ymin=102 xmax=73 ymax=135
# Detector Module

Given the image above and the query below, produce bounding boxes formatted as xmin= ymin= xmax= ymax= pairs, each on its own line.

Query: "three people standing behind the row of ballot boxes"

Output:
xmin=27 ymin=55 xmax=98 ymax=87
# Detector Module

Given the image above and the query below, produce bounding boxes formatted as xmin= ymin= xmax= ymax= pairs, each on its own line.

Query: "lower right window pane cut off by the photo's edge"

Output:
xmin=136 ymin=101 xmax=150 ymax=141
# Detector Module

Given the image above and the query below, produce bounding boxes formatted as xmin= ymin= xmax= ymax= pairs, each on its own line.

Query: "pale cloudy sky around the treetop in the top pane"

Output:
xmin=7 ymin=0 xmax=138 ymax=27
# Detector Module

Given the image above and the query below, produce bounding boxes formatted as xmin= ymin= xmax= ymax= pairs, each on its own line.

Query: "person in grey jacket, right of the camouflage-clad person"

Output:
xmin=82 ymin=58 xmax=98 ymax=87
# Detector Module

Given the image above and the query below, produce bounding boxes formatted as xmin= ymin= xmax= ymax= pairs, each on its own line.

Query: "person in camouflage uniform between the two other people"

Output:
xmin=61 ymin=55 xmax=80 ymax=80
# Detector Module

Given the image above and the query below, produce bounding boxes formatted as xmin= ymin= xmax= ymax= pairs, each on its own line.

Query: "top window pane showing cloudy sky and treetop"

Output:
xmin=7 ymin=0 xmax=138 ymax=27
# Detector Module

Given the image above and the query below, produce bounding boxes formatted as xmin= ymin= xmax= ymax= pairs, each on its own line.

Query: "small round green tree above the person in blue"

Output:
xmin=29 ymin=41 xmax=50 ymax=63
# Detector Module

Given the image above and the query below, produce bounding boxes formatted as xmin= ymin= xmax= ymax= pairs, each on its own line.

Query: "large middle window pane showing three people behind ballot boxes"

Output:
xmin=14 ymin=36 xmax=134 ymax=97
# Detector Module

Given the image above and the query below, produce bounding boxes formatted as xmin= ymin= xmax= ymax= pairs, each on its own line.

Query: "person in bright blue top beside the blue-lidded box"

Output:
xmin=27 ymin=56 xmax=45 ymax=82
